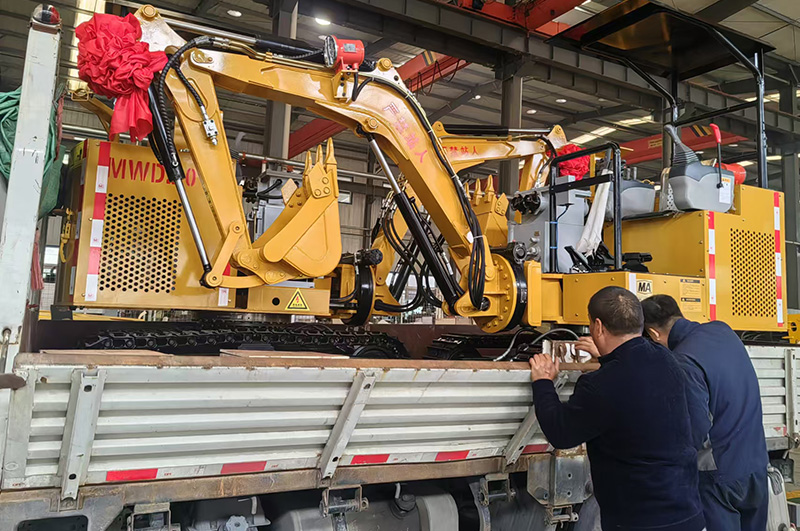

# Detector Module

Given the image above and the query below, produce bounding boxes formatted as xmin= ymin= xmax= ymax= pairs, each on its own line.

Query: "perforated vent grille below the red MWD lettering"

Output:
xmin=98 ymin=194 xmax=182 ymax=293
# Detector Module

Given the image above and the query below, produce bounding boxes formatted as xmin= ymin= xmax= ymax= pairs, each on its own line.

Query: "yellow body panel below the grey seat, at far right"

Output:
xmin=600 ymin=185 xmax=787 ymax=331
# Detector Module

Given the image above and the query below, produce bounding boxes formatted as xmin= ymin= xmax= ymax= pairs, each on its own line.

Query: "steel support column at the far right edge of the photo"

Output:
xmin=780 ymin=86 xmax=800 ymax=310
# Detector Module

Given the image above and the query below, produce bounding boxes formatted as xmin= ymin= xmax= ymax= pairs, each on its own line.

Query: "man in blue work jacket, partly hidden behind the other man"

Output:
xmin=642 ymin=295 xmax=769 ymax=531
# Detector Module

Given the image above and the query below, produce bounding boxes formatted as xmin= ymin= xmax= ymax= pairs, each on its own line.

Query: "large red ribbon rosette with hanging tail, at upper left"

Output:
xmin=75 ymin=13 xmax=167 ymax=140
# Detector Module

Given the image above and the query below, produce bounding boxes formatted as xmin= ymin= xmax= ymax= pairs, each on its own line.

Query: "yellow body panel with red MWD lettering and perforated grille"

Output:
xmin=55 ymin=140 xmax=235 ymax=309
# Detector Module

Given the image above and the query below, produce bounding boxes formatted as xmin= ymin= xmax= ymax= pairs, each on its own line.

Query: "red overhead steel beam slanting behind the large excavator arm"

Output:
xmin=289 ymin=51 xmax=469 ymax=158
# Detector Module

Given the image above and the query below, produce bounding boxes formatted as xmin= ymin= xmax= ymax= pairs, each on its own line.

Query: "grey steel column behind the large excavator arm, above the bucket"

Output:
xmin=263 ymin=0 xmax=297 ymax=159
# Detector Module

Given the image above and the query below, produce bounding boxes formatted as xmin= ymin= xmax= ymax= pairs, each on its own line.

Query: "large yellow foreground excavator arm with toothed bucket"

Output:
xmin=136 ymin=6 xmax=527 ymax=331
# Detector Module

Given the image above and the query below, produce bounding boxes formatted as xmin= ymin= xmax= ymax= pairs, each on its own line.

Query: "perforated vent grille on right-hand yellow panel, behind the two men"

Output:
xmin=731 ymin=229 xmax=777 ymax=317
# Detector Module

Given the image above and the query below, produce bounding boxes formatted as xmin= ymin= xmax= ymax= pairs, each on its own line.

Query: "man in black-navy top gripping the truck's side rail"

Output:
xmin=531 ymin=287 xmax=704 ymax=531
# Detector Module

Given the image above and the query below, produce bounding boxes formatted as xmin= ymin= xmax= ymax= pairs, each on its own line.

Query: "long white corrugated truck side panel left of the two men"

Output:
xmin=2 ymin=354 xmax=579 ymax=497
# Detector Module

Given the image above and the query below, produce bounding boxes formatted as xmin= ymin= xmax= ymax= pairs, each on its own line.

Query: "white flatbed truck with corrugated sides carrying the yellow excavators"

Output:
xmin=0 ymin=346 xmax=800 ymax=531
